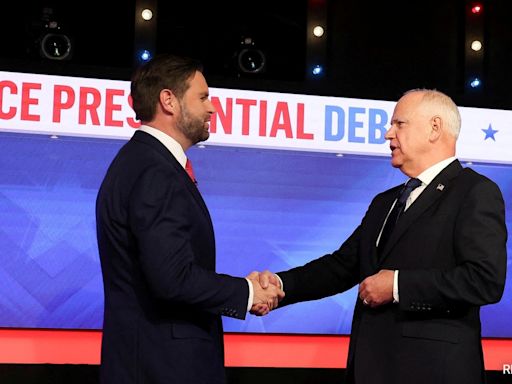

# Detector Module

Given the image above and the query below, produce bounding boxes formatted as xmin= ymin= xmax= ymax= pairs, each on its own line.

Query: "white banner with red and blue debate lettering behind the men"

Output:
xmin=0 ymin=72 xmax=512 ymax=163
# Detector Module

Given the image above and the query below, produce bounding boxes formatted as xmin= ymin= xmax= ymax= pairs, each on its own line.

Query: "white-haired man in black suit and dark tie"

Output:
xmin=253 ymin=90 xmax=507 ymax=384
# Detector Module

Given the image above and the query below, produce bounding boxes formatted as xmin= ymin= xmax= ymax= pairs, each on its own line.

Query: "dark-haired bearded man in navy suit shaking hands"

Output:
xmin=96 ymin=55 xmax=283 ymax=384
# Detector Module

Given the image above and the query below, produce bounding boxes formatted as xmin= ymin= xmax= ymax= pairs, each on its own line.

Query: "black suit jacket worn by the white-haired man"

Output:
xmin=279 ymin=161 xmax=507 ymax=384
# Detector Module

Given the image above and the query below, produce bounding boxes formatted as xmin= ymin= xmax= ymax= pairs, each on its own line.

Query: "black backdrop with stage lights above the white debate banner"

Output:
xmin=0 ymin=0 xmax=512 ymax=109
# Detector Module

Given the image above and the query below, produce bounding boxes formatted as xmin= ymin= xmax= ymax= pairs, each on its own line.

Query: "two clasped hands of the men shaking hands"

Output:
xmin=246 ymin=271 xmax=284 ymax=316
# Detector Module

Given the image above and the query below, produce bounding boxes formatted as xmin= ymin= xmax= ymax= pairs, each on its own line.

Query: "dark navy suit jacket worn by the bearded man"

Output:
xmin=96 ymin=131 xmax=249 ymax=384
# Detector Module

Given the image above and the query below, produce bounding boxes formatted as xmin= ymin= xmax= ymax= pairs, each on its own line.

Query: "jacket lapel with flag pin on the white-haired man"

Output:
xmin=380 ymin=160 xmax=463 ymax=262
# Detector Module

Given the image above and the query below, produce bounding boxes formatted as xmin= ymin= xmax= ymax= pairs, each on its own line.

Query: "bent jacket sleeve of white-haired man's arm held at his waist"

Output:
xmin=398 ymin=179 xmax=507 ymax=313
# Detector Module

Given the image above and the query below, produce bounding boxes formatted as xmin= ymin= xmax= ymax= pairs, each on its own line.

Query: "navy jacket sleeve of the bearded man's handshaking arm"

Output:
xmin=129 ymin=167 xmax=249 ymax=319
